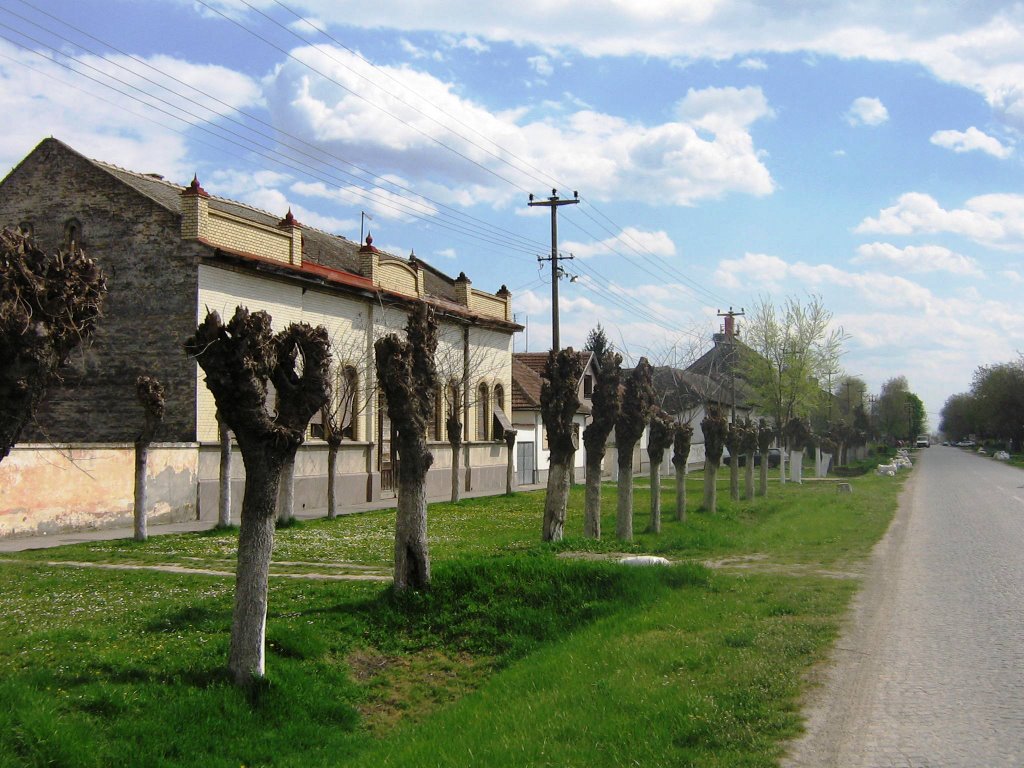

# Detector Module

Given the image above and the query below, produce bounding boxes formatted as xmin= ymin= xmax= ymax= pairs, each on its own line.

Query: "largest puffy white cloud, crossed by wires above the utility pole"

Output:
xmin=265 ymin=46 xmax=774 ymax=205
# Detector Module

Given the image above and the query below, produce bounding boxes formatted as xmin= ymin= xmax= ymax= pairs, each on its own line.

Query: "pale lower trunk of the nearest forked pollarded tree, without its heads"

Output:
xmin=227 ymin=455 xmax=282 ymax=685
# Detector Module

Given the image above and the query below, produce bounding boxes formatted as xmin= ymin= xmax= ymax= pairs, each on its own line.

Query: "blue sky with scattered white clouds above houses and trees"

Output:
xmin=0 ymin=0 xmax=1024 ymax=429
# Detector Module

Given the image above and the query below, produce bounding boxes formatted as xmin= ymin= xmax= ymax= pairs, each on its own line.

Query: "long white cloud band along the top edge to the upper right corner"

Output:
xmin=239 ymin=0 xmax=1024 ymax=131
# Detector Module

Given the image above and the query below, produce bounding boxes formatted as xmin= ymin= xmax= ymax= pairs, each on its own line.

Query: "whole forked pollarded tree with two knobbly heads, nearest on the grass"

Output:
xmin=184 ymin=306 xmax=331 ymax=685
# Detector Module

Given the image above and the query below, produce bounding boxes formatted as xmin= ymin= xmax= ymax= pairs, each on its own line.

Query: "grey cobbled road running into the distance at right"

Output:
xmin=783 ymin=445 xmax=1024 ymax=768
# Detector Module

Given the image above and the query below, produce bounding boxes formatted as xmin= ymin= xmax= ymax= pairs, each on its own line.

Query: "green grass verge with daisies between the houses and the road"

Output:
xmin=0 ymin=472 xmax=899 ymax=767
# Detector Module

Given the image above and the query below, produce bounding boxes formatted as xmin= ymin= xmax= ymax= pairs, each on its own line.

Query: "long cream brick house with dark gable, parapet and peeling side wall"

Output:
xmin=0 ymin=138 xmax=520 ymax=536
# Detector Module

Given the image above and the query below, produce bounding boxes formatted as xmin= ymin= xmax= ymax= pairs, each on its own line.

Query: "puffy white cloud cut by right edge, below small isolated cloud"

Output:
xmin=855 ymin=193 xmax=1024 ymax=250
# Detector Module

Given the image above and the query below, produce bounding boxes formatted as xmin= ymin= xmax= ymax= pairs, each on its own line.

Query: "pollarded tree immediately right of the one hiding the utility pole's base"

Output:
xmin=583 ymin=333 xmax=623 ymax=539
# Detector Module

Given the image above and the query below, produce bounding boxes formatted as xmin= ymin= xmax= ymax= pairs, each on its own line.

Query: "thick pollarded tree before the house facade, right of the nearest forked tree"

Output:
xmin=374 ymin=304 xmax=437 ymax=591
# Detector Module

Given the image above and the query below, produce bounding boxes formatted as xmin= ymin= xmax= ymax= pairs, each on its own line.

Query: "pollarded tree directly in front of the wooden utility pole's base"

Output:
xmin=541 ymin=347 xmax=584 ymax=542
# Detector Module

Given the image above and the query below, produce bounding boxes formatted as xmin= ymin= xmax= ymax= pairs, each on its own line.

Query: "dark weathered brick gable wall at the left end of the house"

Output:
xmin=0 ymin=140 xmax=198 ymax=442
